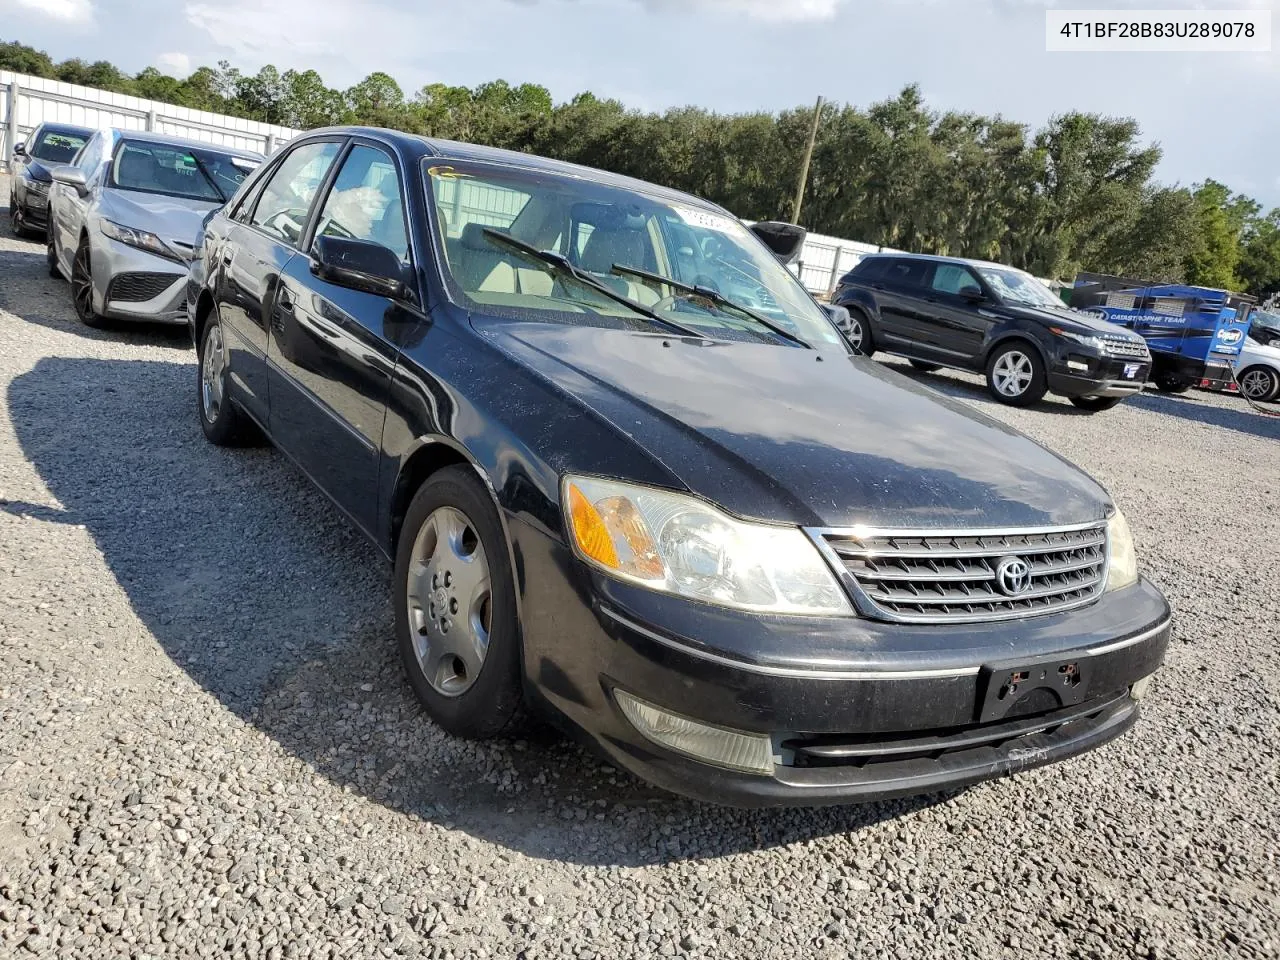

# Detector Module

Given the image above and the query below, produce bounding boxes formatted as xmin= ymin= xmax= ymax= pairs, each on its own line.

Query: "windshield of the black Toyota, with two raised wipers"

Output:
xmin=426 ymin=163 xmax=842 ymax=347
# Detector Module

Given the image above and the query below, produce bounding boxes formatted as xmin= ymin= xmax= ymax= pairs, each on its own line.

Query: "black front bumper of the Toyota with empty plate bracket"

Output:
xmin=512 ymin=521 xmax=1170 ymax=806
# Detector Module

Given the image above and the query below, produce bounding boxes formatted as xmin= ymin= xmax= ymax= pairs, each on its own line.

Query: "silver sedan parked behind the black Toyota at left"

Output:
xmin=47 ymin=129 xmax=262 ymax=326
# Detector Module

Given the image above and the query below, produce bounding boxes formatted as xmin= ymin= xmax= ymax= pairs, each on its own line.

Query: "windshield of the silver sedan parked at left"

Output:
xmin=111 ymin=140 xmax=257 ymax=204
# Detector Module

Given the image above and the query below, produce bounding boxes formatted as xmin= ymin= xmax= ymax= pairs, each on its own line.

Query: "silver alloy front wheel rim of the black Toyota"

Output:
xmin=407 ymin=507 xmax=493 ymax=698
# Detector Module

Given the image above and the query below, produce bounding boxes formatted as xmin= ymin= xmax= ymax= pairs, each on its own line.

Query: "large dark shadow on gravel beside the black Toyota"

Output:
xmin=0 ymin=358 xmax=941 ymax=867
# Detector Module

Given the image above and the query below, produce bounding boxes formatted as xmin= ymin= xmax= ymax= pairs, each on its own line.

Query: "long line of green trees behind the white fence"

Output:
xmin=0 ymin=42 xmax=1280 ymax=297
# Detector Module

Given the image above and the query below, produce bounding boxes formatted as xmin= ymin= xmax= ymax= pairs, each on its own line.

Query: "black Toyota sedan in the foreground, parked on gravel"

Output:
xmin=189 ymin=129 xmax=1170 ymax=805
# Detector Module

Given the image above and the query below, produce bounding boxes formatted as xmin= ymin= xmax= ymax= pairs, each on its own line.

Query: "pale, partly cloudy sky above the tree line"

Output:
xmin=0 ymin=0 xmax=1280 ymax=206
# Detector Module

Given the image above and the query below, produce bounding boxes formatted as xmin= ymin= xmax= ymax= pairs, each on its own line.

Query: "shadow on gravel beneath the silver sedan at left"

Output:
xmin=0 ymin=245 xmax=191 ymax=349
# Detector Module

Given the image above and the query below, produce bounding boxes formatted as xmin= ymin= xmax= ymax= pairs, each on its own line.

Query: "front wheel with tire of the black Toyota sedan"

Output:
xmin=392 ymin=466 xmax=524 ymax=740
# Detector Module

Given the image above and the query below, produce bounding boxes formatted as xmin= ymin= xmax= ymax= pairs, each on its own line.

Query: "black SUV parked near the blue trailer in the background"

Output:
xmin=835 ymin=253 xmax=1151 ymax=411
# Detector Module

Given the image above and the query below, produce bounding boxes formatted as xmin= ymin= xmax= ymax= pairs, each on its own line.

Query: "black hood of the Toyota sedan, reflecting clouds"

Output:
xmin=476 ymin=320 xmax=1110 ymax=529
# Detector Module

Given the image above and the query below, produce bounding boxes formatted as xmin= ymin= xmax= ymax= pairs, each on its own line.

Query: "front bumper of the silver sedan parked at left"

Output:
xmin=92 ymin=236 xmax=187 ymax=324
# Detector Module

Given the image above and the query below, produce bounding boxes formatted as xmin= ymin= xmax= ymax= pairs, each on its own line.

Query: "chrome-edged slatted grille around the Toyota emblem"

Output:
xmin=817 ymin=524 xmax=1107 ymax=623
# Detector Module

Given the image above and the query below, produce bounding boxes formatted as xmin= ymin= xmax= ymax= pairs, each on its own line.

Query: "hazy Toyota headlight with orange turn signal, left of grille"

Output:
xmin=561 ymin=476 xmax=852 ymax=617
